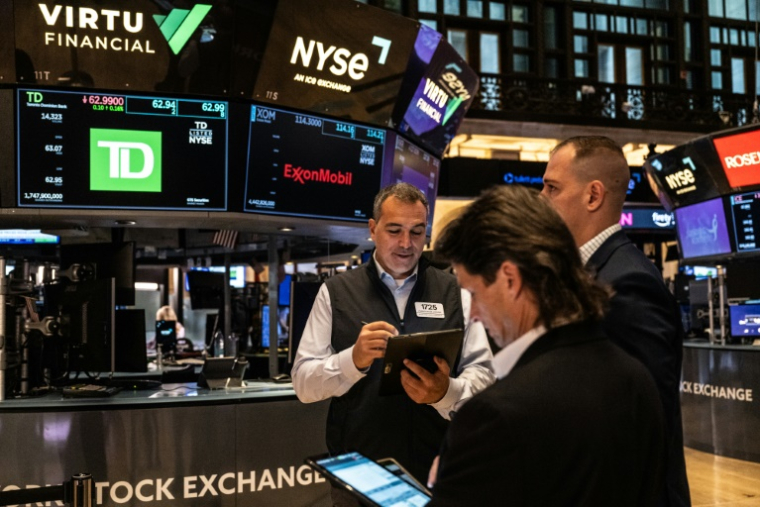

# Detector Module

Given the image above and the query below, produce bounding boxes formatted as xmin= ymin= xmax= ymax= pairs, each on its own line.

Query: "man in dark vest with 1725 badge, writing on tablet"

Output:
xmin=292 ymin=183 xmax=494 ymax=505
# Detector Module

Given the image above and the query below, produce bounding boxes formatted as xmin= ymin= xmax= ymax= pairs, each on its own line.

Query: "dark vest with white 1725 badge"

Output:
xmin=326 ymin=259 xmax=464 ymax=484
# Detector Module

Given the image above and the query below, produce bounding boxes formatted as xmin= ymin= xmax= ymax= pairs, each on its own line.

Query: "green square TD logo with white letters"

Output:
xmin=90 ymin=129 xmax=161 ymax=192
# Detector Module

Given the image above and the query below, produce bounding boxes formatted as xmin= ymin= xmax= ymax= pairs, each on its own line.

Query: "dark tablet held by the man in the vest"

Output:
xmin=380 ymin=329 xmax=464 ymax=396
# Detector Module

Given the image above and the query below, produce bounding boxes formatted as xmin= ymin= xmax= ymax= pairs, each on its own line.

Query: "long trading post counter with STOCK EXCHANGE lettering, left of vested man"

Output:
xmin=0 ymin=382 xmax=330 ymax=507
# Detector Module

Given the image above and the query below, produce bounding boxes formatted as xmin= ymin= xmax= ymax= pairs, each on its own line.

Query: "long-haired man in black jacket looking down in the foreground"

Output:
xmin=428 ymin=187 xmax=665 ymax=507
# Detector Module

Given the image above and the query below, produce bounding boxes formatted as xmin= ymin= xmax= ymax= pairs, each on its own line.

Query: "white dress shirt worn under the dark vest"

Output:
xmin=291 ymin=261 xmax=495 ymax=420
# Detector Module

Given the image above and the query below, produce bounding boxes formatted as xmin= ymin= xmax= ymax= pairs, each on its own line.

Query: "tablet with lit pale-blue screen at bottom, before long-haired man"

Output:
xmin=306 ymin=452 xmax=430 ymax=507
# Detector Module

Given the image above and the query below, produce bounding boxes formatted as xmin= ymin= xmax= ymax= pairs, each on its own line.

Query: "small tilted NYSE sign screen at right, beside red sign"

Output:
xmin=644 ymin=137 xmax=730 ymax=209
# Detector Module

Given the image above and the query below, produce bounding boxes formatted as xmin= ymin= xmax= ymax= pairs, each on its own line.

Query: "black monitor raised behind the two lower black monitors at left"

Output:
xmin=61 ymin=242 xmax=135 ymax=306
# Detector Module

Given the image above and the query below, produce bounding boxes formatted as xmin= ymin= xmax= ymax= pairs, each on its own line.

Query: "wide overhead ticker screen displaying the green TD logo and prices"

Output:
xmin=17 ymin=89 xmax=229 ymax=211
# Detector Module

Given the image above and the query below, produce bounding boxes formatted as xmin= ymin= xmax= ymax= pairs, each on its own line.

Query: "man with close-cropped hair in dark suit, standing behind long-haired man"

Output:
xmin=541 ymin=136 xmax=691 ymax=507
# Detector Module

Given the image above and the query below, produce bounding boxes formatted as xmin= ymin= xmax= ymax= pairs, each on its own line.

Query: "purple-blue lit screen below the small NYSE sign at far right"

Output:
xmin=676 ymin=197 xmax=731 ymax=259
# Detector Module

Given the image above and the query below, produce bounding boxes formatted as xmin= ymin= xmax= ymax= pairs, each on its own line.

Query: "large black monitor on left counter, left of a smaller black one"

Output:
xmin=45 ymin=278 xmax=116 ymax=372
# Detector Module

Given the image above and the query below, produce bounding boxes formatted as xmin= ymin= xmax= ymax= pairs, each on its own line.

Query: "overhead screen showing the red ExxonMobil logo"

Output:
xmin=244 ymin=106 xmax=386 ymax=222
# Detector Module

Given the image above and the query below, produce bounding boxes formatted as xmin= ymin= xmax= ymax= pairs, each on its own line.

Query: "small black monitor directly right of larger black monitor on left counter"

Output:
xmin=114 ymin=309 xmax=148 ymax=372
